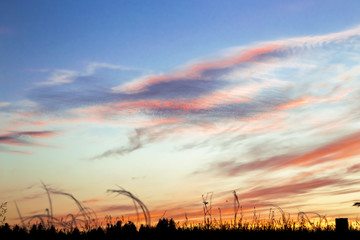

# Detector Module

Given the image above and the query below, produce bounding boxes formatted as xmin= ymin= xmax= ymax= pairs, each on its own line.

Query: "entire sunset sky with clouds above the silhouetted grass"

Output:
xmin=0 ymin=0 xmax=360 ymax=226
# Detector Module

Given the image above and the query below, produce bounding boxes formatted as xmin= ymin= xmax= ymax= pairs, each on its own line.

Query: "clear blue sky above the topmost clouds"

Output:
xmin=4 ymin=1 xmax=360 ymax=101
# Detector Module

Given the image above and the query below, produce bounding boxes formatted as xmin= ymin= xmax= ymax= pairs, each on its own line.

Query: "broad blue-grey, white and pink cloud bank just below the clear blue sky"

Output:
xmin=14 ymin=27 xmax=360 ymax=159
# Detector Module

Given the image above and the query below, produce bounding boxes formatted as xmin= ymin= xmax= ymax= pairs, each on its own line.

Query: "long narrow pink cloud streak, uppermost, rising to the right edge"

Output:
xmin=118 ymin=27 xmax=360 ymax=93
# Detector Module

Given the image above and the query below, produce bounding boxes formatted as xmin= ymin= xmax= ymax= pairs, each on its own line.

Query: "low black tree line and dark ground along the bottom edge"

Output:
xmin=0 ymin=218 xmax=360 ymax=240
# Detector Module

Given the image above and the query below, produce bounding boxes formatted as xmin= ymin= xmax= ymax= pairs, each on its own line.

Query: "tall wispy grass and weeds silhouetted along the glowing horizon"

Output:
xmin=0 ymin=183 xmax=360 ymax=240
